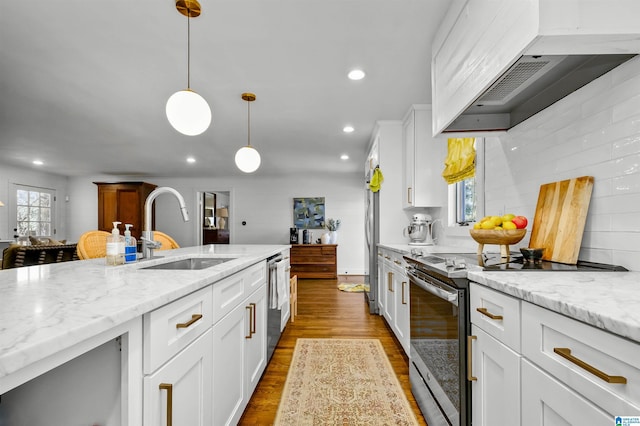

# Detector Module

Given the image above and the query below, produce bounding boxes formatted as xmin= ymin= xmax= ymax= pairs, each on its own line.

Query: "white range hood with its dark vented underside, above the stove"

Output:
xmin=431 ymin=0 xmax=640 ymax=135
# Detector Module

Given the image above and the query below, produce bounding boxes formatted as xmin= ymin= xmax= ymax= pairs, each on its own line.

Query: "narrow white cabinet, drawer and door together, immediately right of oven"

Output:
xmin=469 ymin=284 xmax=520 ymax=426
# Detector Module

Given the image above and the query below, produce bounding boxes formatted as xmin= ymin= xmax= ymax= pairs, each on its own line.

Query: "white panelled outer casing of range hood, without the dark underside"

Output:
xmin=431 ymin=0 xmax=640 ymax=134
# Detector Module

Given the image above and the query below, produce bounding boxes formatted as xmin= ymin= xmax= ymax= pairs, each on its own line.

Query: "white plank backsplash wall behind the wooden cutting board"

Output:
xmin=442 ymin=58 xmax=640 ymax=271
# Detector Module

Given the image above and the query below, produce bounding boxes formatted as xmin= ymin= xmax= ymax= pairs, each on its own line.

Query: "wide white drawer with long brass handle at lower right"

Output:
xmin=522 ymin=302 xmax=640 ymax=415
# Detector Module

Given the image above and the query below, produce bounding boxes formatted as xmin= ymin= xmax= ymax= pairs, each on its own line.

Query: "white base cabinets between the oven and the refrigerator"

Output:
xmin=378 ymin=248 xmax=409 ymax=355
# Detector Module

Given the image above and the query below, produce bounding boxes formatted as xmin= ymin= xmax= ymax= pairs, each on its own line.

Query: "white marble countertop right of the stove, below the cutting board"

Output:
xmin=468 ymin=268 xmax=640 ymax=343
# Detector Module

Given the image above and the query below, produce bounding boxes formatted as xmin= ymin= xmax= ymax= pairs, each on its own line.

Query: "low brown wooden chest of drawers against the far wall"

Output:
xmin=291 ymin=244 xmax=338 ymax=279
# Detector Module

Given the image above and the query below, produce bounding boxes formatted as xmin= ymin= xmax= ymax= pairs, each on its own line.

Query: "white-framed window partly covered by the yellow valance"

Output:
xmin=448 ymin=138 xmax=484 ymax=226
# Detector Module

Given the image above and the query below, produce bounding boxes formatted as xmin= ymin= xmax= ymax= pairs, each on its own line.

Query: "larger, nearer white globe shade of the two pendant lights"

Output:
xmin=166 ymin=89 xmax=211 ymax=136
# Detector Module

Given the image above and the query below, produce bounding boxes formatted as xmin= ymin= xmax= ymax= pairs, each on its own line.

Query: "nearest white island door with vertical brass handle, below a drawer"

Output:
xmin=144 ymin=329 xmax=213 ymax=426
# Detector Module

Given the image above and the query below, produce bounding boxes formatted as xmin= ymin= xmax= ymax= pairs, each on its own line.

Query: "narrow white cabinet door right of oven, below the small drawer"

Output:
xmin=470 ymin=325 xmax=521 ymax=426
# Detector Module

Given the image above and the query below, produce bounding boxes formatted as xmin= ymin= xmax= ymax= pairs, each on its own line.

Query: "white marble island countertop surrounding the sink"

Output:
xmin=0 ymin=245 xmax=290 ymax=380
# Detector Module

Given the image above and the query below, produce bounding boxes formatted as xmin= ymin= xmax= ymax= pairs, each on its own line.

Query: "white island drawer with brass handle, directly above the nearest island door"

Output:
xmin=143 ymin=286 xmax=213 ymax=374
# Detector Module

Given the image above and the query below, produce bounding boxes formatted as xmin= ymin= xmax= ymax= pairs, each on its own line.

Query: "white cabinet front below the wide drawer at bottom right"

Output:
xmin=522 ymin=359 xmax=608 ymax=426
